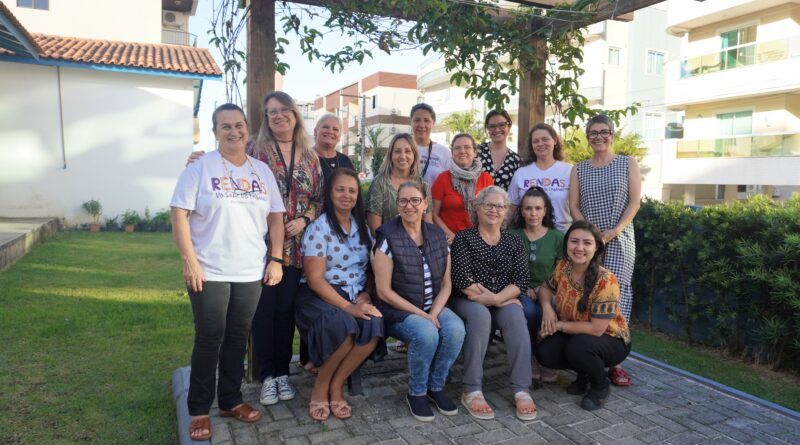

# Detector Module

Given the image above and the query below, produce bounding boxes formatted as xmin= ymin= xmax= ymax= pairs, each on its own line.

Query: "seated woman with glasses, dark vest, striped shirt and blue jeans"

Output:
xmin=372 ymin=182 xmax=466 ymax=422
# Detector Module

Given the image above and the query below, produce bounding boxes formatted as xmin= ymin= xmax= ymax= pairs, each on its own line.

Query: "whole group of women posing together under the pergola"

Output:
xmin=171 ymin=92 xmax=640 ymax=440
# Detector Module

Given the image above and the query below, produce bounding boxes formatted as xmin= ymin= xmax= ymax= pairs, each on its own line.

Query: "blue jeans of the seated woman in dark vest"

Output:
xmin=386 ymin=308 xmax=466 ymax=396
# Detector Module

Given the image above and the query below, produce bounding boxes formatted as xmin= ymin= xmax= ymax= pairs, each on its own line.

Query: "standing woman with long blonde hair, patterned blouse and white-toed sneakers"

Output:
xmin=250 ymin=91 xmax=323 ymax=405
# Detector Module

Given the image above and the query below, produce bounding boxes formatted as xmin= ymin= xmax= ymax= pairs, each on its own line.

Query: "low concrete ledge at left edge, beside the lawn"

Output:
xmin=0 ymin=218 xmax=60 ymax=272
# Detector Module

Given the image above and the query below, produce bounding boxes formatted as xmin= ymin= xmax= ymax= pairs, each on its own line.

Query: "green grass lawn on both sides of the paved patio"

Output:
xmin=0 ymin=232 xmax=800 ymax=444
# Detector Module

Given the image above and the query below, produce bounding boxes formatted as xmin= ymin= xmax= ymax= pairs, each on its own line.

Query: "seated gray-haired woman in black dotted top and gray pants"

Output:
xmin=450 ymin=186 xmax=536 ymax=421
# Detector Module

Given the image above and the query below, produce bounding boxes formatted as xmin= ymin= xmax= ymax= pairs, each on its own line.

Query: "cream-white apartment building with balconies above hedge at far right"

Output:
xmin=662 ymin=0 xmax=800 ymax=204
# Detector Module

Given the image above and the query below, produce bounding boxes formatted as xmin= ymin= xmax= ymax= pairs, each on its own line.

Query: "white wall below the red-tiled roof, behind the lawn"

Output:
xmin=0 ymin=62 xmax=193 ymax=224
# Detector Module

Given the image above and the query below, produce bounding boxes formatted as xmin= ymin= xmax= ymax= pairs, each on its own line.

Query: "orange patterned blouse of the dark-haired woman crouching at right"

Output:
xmin=547 ymin=260 xmax=631 ymax=344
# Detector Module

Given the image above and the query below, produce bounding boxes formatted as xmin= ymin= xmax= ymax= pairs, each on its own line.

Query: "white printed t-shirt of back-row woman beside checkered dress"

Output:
xmin=508 ymin=161 xmax=572 ymax=232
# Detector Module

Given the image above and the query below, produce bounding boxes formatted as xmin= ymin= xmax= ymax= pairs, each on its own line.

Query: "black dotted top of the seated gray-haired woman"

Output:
xmin=450 ymin=227 xmax=528 ymax=297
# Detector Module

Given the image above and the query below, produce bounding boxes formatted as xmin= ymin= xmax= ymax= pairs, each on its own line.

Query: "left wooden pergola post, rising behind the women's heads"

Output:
xmin=247 ymin=0 xmax=275 ymax=138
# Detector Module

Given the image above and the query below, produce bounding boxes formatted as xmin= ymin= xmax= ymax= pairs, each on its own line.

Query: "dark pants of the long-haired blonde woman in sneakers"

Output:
xmin=253 ymin=266 xmax=303 ymax=381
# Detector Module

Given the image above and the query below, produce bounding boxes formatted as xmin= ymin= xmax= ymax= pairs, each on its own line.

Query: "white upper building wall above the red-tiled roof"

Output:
xmin=8 ymin=0 xmax=161 ymax=43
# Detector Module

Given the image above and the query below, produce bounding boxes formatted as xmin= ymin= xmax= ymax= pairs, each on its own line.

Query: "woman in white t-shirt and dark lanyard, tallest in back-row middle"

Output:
xmin=411 ymin=102 xmax=453 ymax=187
